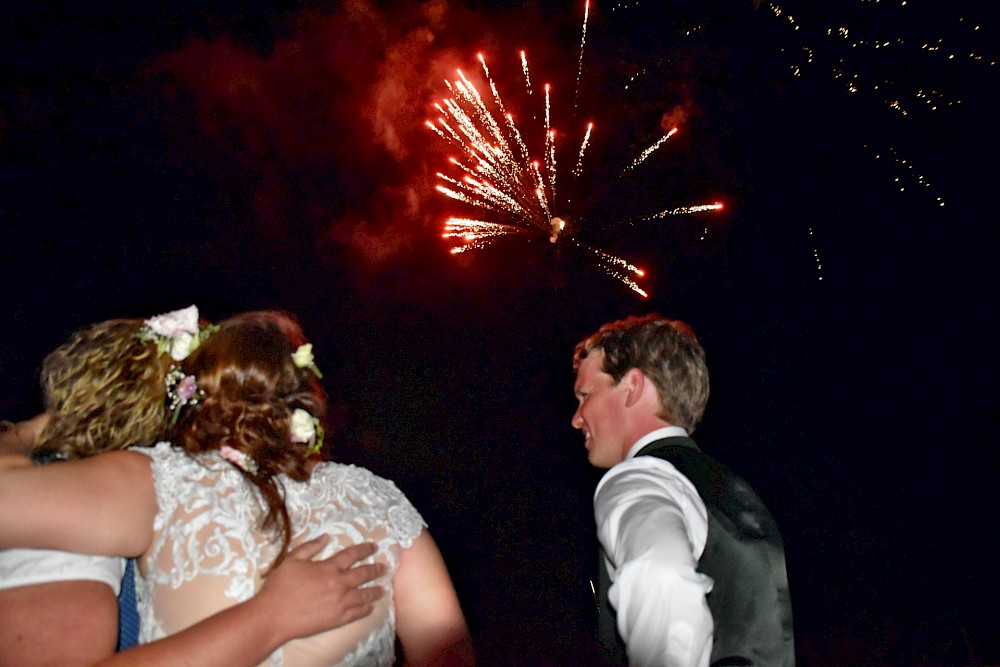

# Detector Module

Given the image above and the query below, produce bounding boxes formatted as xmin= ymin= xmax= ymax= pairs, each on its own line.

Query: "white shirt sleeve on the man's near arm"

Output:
xmin=594 ymin=456 xmax=712 ymax=667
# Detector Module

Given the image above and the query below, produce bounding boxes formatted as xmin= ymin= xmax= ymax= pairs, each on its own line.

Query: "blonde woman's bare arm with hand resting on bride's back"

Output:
xmin=0 ymin=537 xmax=385 ymax=667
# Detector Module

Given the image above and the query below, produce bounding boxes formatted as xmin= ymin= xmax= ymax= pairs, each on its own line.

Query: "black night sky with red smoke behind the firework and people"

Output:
xmin=0 ymin=0 xmax=1000 ymax=666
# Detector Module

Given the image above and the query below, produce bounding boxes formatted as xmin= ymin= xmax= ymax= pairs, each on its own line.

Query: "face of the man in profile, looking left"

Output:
xmin=573 ymin=349 xmax=631 ymax=468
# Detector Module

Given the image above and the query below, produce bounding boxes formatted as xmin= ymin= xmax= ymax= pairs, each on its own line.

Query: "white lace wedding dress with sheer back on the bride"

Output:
xmin=134 ymin=442 xmax=425 ymax=667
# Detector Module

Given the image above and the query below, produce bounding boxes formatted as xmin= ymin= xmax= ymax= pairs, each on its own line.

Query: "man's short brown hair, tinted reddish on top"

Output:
xmin=573 ymin=313 xmax=709 ymax=433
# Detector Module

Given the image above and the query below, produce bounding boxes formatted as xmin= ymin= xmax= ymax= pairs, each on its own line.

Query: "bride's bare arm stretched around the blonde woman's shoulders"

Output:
xmin=0 ymin=452 xmax=157 ymax=556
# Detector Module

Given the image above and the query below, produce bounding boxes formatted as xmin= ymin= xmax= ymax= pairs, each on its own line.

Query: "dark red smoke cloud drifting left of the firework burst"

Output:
xmin=155 ymin=0 xmax=490 ymax=262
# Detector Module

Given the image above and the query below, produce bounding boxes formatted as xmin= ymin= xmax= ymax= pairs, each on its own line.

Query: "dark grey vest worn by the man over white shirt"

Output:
xmin=598 ymin=438 xmax=795 ymax=667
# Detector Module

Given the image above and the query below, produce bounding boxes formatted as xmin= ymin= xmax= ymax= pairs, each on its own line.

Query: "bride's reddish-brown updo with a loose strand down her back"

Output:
xmin=171 ymin=311 xmax=326 ymax=565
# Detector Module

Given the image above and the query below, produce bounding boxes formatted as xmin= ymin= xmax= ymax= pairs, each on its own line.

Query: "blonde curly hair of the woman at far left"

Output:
xmin=36 ymin=319 xmax=171 ymax=459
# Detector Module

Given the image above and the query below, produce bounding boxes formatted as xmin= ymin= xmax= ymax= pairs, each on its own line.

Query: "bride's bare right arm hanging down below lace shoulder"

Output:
xmin=392 ymin=530 xmax=476 ymax=667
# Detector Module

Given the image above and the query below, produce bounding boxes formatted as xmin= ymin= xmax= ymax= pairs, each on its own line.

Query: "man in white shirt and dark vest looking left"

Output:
xmin=573 ymin=315 xmax=794 ymax=667
